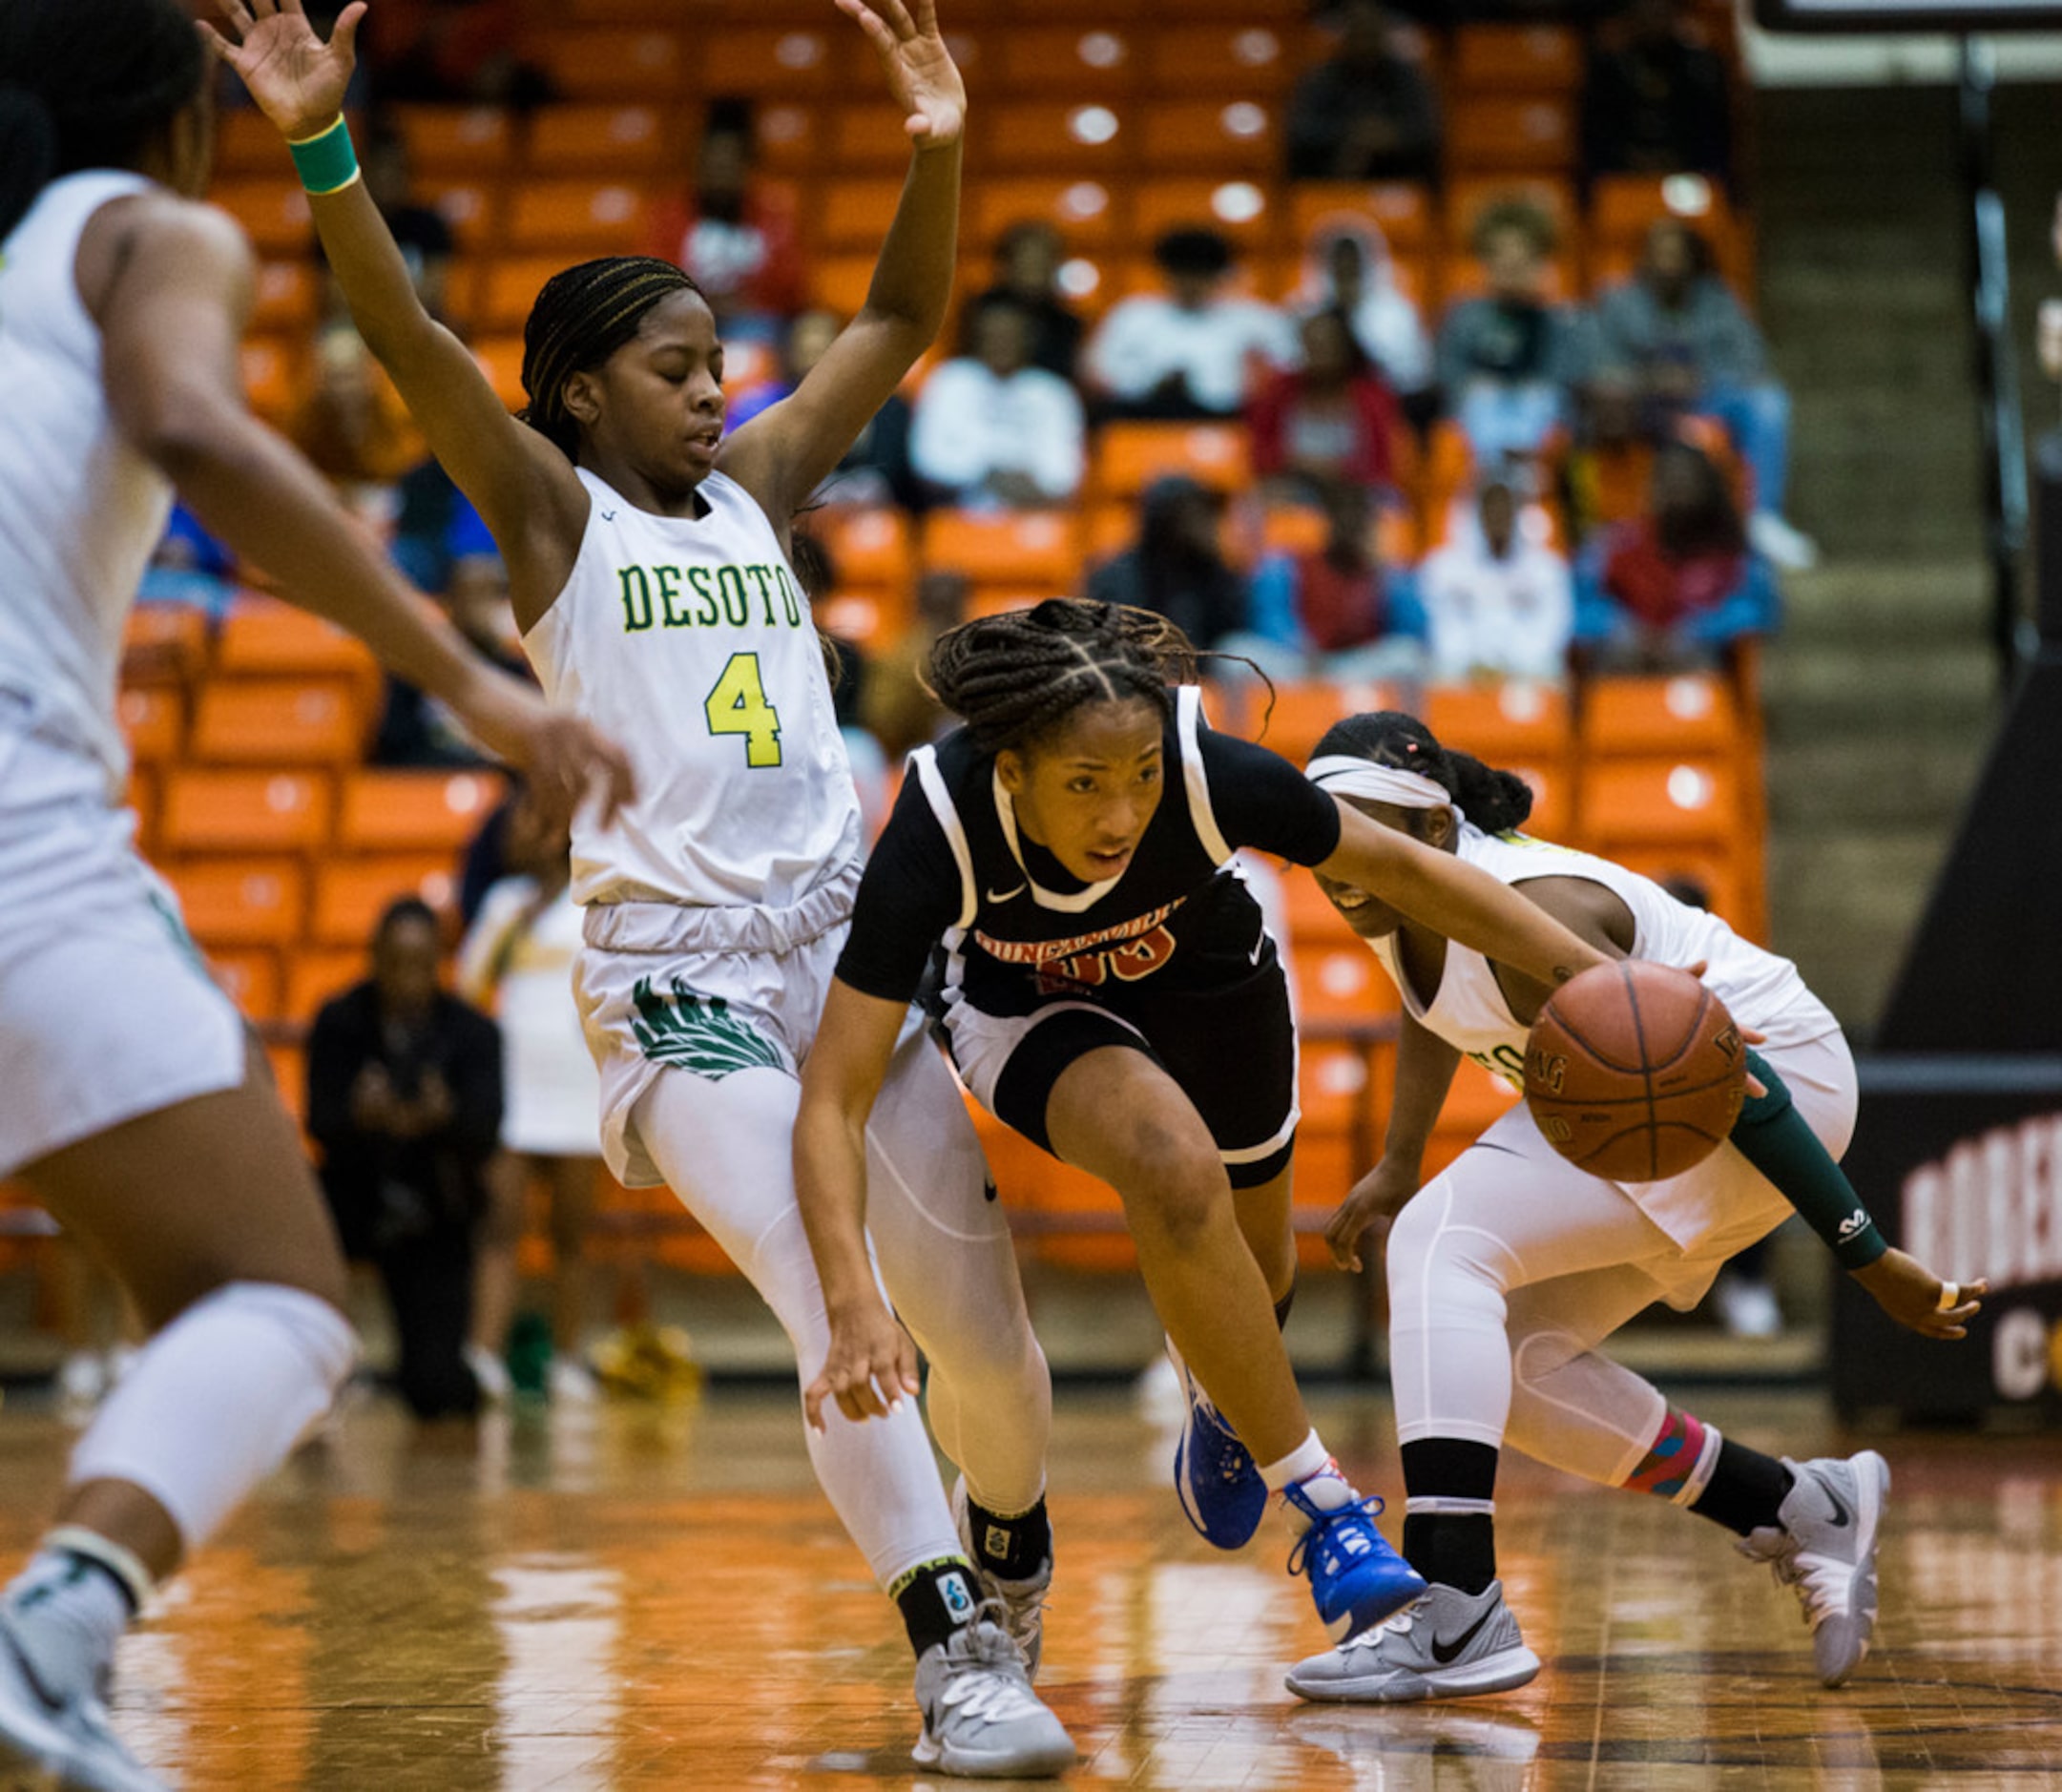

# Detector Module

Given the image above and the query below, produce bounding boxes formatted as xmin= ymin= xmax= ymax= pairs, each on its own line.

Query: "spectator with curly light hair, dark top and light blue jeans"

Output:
xmin=1437 ymin=198 xmax=1590 ymax=466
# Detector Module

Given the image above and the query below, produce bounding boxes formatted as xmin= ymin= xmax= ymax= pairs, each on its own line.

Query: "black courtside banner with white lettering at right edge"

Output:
xmin=1831 ymin=1055 xmax=2062 ymax=1425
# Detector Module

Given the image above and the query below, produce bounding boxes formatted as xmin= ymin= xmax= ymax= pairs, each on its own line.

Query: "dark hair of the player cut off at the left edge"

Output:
xmin=0 ymin=0 xmax=206 ymax=238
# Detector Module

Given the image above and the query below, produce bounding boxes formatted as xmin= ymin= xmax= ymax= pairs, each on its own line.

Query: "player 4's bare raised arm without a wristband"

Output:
xmin=718 ymin=0 xmax=968 ymax=532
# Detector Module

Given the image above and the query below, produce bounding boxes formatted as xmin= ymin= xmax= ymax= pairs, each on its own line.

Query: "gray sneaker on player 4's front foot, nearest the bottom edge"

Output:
xmin=915 ymin=1600 xmax=1076 ymax=1780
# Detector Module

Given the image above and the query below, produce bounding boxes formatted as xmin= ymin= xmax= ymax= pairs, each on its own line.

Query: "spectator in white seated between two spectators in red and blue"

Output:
xmin=1419 ymin=478 xmax=1575 ymax=682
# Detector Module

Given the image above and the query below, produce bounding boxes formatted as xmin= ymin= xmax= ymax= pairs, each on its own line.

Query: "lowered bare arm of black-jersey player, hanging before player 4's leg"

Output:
xmin=794 ymin=977 xmax=918 ymax=1431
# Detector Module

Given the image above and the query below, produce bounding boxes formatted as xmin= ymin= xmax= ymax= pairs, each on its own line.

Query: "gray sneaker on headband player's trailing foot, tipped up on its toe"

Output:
xmin=1734 ymin=1449 xmax=1891 ymax=1687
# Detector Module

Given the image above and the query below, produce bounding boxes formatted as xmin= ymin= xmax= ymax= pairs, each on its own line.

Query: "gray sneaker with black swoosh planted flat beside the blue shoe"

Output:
xmin=1289 ymin=1579 xmax=1540 ymax=1705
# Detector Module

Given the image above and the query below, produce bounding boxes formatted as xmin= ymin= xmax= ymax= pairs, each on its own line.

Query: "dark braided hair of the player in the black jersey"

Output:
xmin=924 ymin=598 xmax=1196 ymax=753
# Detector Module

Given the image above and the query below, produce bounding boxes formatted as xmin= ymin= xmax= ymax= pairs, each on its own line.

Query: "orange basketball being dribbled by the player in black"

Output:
xmin=1526 ymin=959 xmax=1746 ymax=1181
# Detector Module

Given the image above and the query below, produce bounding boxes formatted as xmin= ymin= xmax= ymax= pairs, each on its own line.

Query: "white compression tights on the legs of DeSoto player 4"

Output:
xmin=635 ymin=1031 xmax=1052 ymax=1586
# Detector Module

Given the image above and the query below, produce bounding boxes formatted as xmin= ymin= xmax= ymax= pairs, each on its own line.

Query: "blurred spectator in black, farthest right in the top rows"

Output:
xmin=1581 ymin=0 xmax=1732 ymax=183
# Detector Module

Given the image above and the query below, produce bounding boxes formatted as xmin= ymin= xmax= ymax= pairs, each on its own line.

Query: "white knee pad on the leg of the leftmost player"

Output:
xmin=70 ymin=1282 xmax=357 ymax=1549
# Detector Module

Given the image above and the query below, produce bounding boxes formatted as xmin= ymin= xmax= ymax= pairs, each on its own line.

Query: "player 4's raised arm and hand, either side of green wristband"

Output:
xmin=206 ymin=0 xmax=588 ymax=606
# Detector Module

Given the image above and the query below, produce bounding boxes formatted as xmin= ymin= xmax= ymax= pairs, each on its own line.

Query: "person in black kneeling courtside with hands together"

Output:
xmin=307 ymin=897 xmax=501 ymax=1419
